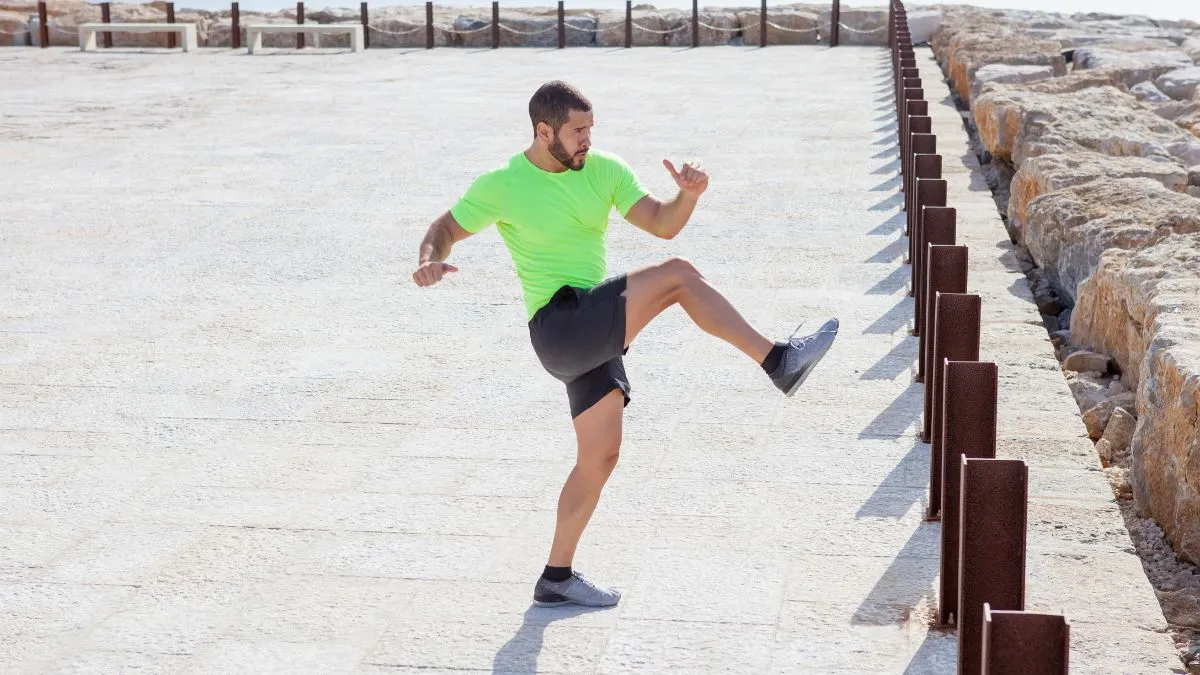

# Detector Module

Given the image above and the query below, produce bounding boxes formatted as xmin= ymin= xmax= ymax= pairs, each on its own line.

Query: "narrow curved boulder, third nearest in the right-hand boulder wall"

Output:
xmin=1008 ymin=151 xmax=1188 ymax=238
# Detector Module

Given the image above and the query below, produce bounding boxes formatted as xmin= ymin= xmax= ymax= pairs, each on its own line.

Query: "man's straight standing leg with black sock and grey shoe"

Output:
xmin=534 ymin=389 xmax=625 ymax=607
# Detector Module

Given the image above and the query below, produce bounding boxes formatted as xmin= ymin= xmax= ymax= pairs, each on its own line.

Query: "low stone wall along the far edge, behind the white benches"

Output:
xmin=0 ymin=0 xmax=907 ymax=48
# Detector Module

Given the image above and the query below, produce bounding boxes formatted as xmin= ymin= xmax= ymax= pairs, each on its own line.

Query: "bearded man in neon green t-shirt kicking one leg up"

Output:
xmin=413 ymin=80 xmax=838 ymax=607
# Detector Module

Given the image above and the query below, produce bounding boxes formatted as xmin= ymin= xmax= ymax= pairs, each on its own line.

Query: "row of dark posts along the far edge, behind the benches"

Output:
xmin=30 ymin=0 xmax=841 ymax=49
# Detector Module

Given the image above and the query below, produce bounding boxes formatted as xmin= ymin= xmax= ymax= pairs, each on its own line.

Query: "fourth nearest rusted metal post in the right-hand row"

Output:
xmin=925 ymin=293 xmax=982 ymax=520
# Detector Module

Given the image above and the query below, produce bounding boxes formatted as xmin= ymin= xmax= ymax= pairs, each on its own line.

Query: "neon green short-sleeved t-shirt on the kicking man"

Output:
xmin=450 ymin=148 xmax=647 ymax=319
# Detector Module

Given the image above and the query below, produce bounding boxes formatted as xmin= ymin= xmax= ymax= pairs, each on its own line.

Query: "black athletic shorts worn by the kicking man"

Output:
xmin=529 ymin=274 xmax=630 ymax=418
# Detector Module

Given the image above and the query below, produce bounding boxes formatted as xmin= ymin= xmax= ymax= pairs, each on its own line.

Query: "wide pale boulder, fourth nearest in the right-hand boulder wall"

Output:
xmin=974 ymin=80 xmax=1200 ymax=166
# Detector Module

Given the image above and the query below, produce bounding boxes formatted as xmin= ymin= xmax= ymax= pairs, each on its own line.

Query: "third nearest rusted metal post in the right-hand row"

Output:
xmin=935 ymin=360 xmax=1000 ymax=626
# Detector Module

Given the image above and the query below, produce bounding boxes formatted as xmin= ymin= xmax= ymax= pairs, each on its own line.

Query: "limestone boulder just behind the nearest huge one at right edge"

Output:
xmin=1022 ymin=178 xmax=1200 ymax=299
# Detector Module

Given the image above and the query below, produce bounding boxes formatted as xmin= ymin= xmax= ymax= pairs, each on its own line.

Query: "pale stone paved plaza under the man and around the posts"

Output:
xmin=0 ymin=47 xmax=1178 ymax=674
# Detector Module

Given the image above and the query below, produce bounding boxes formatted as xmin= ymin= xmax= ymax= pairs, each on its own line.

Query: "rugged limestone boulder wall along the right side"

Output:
xmin=931 ymin=7 xmax=1200 ymax=583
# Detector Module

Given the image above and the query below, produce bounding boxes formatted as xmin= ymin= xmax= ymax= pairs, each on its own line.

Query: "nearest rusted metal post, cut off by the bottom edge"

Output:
xmin=979 ymin=603 xmax=1070 ymax=675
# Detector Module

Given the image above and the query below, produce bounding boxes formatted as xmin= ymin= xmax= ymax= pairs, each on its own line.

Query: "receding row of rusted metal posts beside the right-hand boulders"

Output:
xmin=888 ymin=0 xmax=1070 ymax=675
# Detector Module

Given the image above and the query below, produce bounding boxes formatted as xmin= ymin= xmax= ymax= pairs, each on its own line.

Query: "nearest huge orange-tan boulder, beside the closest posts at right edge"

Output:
xmin=1072 ymin=234 xmax=1200 ymax=563
